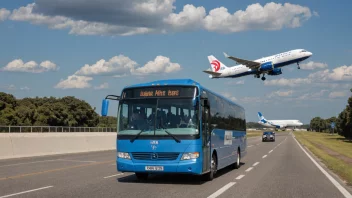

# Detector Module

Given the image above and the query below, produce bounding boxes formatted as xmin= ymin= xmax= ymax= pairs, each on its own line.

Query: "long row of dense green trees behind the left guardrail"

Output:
xmin=0 ymin=92 xmax=117 ymax=127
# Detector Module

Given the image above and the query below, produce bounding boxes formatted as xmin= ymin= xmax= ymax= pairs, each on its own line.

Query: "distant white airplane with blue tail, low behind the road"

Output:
xmin=258 ymin=112 xmax=303 ymax=129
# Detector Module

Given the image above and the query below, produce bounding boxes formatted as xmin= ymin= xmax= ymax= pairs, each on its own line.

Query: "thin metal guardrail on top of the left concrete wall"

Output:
xmin=0 ymin=126 xmax=117 ymax=133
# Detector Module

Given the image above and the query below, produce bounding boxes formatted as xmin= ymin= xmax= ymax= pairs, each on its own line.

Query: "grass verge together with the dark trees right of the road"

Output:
xmin=294 ymin=89 xmax=352 ymax=185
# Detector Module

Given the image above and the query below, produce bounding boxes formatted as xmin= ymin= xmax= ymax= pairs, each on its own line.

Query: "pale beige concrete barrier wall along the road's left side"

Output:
xmin=0 ymin=132 xmax=116 ymax=159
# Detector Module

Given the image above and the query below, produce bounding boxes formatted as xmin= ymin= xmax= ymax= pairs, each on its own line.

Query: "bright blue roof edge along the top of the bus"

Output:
xmin=123 ymin=79 xmax=244 ymax=109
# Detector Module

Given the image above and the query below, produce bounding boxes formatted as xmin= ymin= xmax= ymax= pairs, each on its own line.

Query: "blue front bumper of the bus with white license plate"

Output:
xmin=116 ymin=158 xmax=203 ymax=175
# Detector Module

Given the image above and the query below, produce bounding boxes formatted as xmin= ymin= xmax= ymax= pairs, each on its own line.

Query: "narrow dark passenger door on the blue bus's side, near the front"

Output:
xmin=202 ymin=100 xmax=211 ymax=172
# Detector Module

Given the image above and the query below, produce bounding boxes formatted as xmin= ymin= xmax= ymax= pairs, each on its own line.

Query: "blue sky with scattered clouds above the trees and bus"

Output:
xmin=0 ymin=0 xmax=352 ymax=123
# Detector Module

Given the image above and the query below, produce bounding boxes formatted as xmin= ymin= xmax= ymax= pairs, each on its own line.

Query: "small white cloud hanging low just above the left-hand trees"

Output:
xmin=55 ymin=75 xmax=93 ymax=89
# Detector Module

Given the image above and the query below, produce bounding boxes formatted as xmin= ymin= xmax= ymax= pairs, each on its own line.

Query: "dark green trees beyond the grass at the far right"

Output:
xmin=310 ymin=89 xmax=352 ymax=139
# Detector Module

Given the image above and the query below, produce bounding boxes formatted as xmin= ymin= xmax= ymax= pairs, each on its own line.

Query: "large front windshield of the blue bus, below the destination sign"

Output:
xmin=118 ymin=98 xmax=199 ymax=136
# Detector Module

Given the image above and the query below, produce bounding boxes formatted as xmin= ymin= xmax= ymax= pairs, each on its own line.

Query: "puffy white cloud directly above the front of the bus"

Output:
xmin=134 ymin=56 xmax=181 ymax=75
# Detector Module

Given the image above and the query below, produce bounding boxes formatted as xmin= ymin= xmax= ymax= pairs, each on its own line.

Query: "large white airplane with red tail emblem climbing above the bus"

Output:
xmin=203 ymin=49 xmax=313 ymax=81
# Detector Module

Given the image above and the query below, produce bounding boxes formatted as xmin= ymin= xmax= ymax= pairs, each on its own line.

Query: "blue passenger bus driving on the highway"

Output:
xmin=101 ymin=79 xmax=247 ymax=180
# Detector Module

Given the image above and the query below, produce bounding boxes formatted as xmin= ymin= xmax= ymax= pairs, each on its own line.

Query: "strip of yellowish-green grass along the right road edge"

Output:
xmin=294 ymin=131 xmax=352 ymax=185
